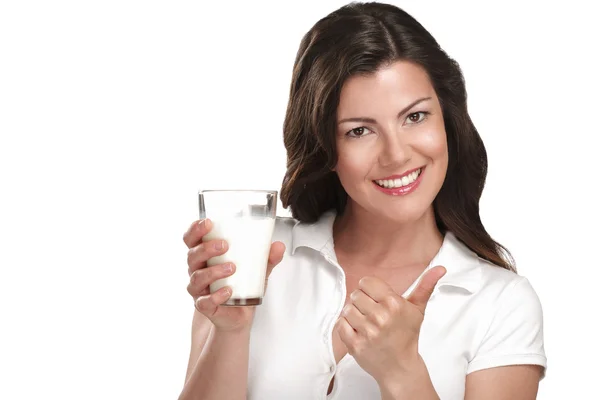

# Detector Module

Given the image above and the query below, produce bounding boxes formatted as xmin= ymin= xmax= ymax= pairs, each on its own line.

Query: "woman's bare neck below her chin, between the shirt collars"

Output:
xmin=333 ymin=204 xmax=443 ymax=269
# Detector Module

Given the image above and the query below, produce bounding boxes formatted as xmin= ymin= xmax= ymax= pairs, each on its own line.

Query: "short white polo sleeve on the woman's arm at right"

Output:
xmin=467 ymin=277 xmax=546 ymax=378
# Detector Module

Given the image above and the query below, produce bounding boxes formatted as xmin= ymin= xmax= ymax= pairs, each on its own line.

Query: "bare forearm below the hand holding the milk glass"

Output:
xmin=179 ymin=327 xmax=250 ymax=400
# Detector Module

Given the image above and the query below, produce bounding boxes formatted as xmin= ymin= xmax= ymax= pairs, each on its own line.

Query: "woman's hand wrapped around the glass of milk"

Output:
xmin=183 ymin=219 xmax=285 ymax=332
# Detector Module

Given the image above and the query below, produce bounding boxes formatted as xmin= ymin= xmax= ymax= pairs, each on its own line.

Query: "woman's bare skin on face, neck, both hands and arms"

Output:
xmin=180 ymin=62 xmax=541 ymax=400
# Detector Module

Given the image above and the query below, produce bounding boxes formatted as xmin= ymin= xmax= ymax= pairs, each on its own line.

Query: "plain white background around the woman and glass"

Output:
xmin=0 ymin=0 xmax=600 ymax=400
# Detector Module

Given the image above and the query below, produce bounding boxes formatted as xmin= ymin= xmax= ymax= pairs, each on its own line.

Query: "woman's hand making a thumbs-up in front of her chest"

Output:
xmin=335 ymin=266 xmax=446 ymax=386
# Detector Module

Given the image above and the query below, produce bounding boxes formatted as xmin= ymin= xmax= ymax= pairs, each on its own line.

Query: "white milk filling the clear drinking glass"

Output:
xmin=203 ymin=216 xmax=275 ymax=299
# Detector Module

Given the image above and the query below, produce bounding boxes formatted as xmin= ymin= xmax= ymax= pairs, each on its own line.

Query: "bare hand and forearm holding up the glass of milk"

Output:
xmin=179 ymin=219 xmax=285 ymax=400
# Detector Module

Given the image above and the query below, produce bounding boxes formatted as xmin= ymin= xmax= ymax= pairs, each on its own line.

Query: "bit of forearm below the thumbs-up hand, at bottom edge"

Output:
xmin=379 ymin=357 xmax=440 ymax=400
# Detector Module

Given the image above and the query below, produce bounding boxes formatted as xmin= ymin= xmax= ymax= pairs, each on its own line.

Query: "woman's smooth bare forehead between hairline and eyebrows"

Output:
xmin=338 ymin=61 xmax=436 ymax=118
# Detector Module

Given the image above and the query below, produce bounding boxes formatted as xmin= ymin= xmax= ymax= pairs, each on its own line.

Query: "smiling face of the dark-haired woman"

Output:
xmin=336 ymin=61 xmax=448 ymax=222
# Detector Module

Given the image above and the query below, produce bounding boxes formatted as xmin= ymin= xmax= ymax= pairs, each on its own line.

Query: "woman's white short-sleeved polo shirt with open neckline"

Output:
xmin=248 ymin=211 xmax=546 ymax=400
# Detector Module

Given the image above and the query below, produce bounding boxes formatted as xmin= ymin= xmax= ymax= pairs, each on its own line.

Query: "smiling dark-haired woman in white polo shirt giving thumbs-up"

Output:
xmin=180 ymin=3 xmax=546 ymax=400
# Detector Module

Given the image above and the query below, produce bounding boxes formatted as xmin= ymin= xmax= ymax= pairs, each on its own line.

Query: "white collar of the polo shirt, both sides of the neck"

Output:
xmin=292 ymin=210 xmax=483 ymax=293
